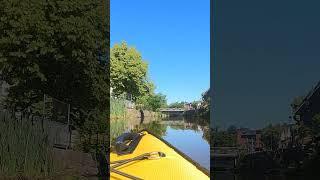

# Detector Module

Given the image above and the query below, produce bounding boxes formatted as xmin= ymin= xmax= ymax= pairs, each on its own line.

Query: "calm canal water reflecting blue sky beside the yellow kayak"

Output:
xmin=126 ymin=117 xmax=210 ymax=170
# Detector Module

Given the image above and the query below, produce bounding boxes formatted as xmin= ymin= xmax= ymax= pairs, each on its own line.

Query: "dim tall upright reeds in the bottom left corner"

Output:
xmin=0 ymin=112 xmax=55 ymax=177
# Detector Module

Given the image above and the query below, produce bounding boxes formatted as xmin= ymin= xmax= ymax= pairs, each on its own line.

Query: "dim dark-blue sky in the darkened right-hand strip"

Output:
xmin=211 ymin=0 xmax=320 ymax=128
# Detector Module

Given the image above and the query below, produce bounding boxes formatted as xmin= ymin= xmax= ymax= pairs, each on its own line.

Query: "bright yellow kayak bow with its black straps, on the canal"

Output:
xmin=110 ymin=130 xmax=210 ymax=180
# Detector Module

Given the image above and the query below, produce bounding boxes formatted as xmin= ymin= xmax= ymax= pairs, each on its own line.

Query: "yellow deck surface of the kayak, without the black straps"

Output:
xmin=110 ymin=131 xmax=210 ymax=180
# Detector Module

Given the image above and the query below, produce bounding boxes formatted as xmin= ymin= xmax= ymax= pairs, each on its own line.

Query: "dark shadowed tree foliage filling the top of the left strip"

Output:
xmin=0 ymin=0 xmax=109 ymax=135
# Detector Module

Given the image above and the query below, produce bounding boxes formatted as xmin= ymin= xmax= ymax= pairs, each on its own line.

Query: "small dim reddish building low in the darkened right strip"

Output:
xmin=237 ymin=128 xmax=262 ymax=152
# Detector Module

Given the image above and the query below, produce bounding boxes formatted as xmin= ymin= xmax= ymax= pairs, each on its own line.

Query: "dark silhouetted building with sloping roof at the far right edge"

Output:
xmin=293 ymin=81 xmax=320 ymax=125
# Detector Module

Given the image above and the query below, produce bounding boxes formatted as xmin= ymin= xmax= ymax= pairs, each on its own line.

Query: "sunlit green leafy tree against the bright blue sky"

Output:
xmin=110 ymin=42 xmax=150 ymax=100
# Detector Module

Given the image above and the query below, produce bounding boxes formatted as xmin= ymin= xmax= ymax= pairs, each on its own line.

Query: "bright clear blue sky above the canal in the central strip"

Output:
xmin=110 ymin=0 xmax=210 ymax=103
